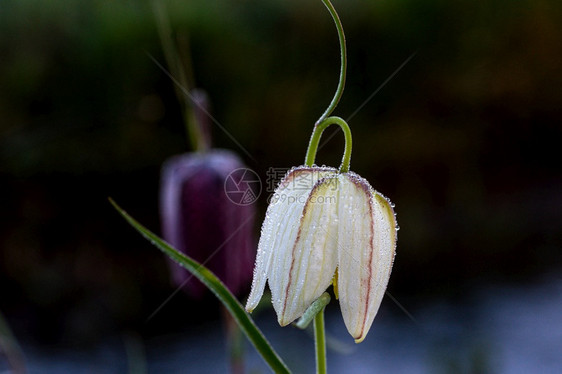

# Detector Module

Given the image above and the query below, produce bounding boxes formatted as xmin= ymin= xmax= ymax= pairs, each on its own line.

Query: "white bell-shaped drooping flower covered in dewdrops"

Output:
xmin=246 ymin=166 xmax=397 ymax=343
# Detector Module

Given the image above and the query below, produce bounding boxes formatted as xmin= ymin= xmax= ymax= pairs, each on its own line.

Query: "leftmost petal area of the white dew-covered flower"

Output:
xmin=246 ymin=167 xmax=334 ymax=315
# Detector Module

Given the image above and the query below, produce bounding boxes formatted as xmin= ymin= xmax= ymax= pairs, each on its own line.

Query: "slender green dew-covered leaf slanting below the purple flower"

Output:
xmin=109 ymin=199 xmax=290 ymax=373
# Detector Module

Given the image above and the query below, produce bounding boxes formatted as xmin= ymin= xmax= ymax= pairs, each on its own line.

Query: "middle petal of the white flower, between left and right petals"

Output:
xmin=278 ymin=176 xmax=338 ymax=326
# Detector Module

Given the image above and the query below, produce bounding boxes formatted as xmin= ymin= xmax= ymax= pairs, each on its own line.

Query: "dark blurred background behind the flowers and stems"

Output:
xmin=0 ymin=0 xmax=562 ymax=372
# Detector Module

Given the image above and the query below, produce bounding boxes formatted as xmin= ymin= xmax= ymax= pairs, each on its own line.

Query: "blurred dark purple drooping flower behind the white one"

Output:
xmin=160 ymin=150 xmax=255 ymax=297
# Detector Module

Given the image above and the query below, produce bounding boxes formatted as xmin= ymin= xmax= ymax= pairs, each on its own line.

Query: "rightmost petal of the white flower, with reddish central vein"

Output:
xmin=338 ymin=173 xmax=396 ymax=343
